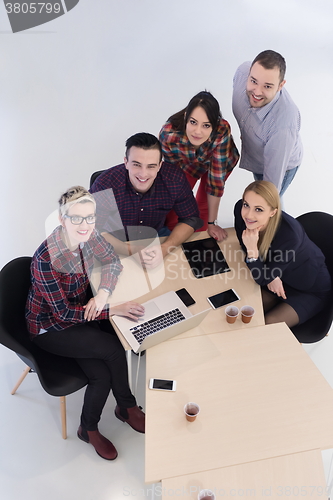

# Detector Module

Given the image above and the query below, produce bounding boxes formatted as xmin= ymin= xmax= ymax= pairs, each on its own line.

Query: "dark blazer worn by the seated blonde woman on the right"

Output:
xmin=234 ymin=200 xmax=331 ymax=293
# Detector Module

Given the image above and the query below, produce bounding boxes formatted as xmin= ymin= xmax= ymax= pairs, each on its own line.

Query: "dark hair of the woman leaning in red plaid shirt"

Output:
xmin=168 ymin=90 xmax=222 ymax=133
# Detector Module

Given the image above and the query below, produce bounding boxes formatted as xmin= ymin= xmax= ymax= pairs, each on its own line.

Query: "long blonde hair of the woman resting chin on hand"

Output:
xmin=243 ymin=181 xmax=281 ymax=260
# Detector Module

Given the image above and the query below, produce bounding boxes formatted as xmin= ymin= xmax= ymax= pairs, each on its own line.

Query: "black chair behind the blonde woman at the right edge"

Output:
xmin=291 ymin=212 xmax=333 ymax=344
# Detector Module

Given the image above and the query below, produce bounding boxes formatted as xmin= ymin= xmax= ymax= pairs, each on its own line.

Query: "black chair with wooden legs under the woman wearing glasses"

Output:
xmin=0 ymin=257 xmax=88 ymax=439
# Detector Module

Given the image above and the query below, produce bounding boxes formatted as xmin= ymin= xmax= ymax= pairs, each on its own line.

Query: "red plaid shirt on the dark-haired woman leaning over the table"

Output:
xmin=159 ymin=119 xmax=239 ymax=197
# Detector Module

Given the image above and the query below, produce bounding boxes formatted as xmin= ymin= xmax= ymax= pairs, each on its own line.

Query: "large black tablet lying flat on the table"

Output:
xmin=182 ymin=238 xmax=230 ymax=278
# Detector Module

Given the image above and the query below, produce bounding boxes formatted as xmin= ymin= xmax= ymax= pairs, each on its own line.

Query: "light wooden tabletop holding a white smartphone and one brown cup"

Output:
xmin=145 ymin=323 xmax=333 ymax=483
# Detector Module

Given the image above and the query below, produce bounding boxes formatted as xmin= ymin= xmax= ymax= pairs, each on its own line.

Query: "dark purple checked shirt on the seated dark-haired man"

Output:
xmin=90 ymin=163 xmax=202 ymax=239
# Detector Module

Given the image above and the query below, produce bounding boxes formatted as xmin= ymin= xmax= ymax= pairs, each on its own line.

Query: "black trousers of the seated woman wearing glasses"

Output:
xmin=34 ymin=321 xmax=136 ymax=431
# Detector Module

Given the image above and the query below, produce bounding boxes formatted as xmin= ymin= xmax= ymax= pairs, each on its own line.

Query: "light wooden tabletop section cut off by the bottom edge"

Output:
xmin=159 ymin=450 xmax=328 ymax=500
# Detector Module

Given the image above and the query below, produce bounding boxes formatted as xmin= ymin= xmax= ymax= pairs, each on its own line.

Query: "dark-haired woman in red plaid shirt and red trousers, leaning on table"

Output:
xmin=159 ymin=91 xmax=239 ymax=241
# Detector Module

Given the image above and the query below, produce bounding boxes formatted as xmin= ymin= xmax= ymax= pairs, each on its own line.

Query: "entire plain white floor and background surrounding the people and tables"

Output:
xmin=0 ymin=0 xmax=333 ymax=500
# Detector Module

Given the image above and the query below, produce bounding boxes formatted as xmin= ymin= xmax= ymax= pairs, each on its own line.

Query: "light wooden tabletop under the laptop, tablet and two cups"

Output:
xmin=92 ymin=228 xmax=264 ymax=349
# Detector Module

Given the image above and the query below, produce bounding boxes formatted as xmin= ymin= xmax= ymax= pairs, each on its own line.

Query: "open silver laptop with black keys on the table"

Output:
xmin=112 ymin=292 xmax=212 ymax=353
